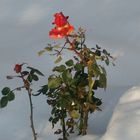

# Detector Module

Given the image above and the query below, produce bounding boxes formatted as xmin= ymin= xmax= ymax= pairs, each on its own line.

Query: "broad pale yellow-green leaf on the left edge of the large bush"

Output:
xmin=48 ymin=77 xmax=62 ymax=88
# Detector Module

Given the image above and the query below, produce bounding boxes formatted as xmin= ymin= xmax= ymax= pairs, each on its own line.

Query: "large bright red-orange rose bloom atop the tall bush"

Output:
xmin=49 ymin=12 xmax=74 ymax=39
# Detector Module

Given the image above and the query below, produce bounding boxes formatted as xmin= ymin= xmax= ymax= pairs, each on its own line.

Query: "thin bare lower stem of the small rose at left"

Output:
xmin=28 ymin=89 xmax=37 ymax=140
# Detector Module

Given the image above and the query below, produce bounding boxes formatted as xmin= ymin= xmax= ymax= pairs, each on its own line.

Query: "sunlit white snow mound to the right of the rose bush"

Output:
xmin=100 ymin=87 xmax=140 ymax=140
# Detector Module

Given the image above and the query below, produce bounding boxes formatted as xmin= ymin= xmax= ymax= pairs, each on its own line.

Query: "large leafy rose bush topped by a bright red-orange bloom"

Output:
xmin=38 ymin=12 xmax=114 ymax=140
